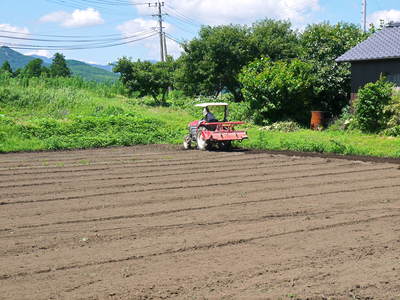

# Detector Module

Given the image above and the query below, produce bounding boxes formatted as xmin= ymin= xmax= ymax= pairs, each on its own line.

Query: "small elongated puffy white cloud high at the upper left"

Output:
xmin=40 ymin=8 xmax=104 ymax=28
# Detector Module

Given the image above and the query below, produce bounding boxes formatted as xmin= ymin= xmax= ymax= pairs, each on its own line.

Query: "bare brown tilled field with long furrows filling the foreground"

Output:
xmin=0 ymin=145 xmax=400 ymax=299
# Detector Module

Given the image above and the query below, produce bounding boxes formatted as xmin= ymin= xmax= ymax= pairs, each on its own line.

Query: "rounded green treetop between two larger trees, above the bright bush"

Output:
xmin=250 ymin=19 xmax=299 ymax=61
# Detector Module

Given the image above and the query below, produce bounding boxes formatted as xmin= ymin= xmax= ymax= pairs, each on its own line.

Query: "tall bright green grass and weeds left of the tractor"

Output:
xmin=0 ymin=75 xmax=192 ymax=152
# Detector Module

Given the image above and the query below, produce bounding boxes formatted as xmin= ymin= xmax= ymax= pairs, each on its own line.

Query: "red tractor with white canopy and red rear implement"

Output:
xmin=183 ymin=103 xmax=248 ymax=150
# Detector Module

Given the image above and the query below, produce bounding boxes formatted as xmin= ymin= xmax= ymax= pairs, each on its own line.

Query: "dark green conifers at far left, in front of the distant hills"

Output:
xmin=0 ymin=53 xmax=72 ymax=78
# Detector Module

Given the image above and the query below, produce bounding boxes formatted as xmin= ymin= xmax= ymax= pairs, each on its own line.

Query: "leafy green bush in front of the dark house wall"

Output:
xmin=355 ymin=78 xmax=394 ymax=133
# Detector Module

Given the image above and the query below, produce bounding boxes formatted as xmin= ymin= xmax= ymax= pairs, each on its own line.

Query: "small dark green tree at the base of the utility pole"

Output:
xmin=113 ymin=57 xmax=175 ymax=105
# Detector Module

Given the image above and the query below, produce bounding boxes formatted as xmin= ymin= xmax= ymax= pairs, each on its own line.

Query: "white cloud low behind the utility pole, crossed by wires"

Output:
xmin=117 ymin=18 xmax=182 ymax=59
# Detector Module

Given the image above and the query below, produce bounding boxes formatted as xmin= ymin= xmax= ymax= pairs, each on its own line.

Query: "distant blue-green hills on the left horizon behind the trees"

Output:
xmin=0 ymin=47 xmax=118 ymax=82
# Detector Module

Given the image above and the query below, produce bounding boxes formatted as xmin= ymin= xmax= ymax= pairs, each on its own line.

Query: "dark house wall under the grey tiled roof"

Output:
xmin=351 ymin=59 xmax=400 ymax=93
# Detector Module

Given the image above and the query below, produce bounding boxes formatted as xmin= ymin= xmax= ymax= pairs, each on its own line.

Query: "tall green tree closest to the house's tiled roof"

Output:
xmin=300 ymin=23 xmax=369 ymax=115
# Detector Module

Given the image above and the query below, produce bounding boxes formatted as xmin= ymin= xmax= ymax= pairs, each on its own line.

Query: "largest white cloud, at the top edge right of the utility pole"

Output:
xmin=134 ymin=0 xmax=320 ymax=25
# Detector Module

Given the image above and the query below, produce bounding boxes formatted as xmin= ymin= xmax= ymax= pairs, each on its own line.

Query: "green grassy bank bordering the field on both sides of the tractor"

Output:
xmin=0 ymin=77 xmax=400 ymax=157
